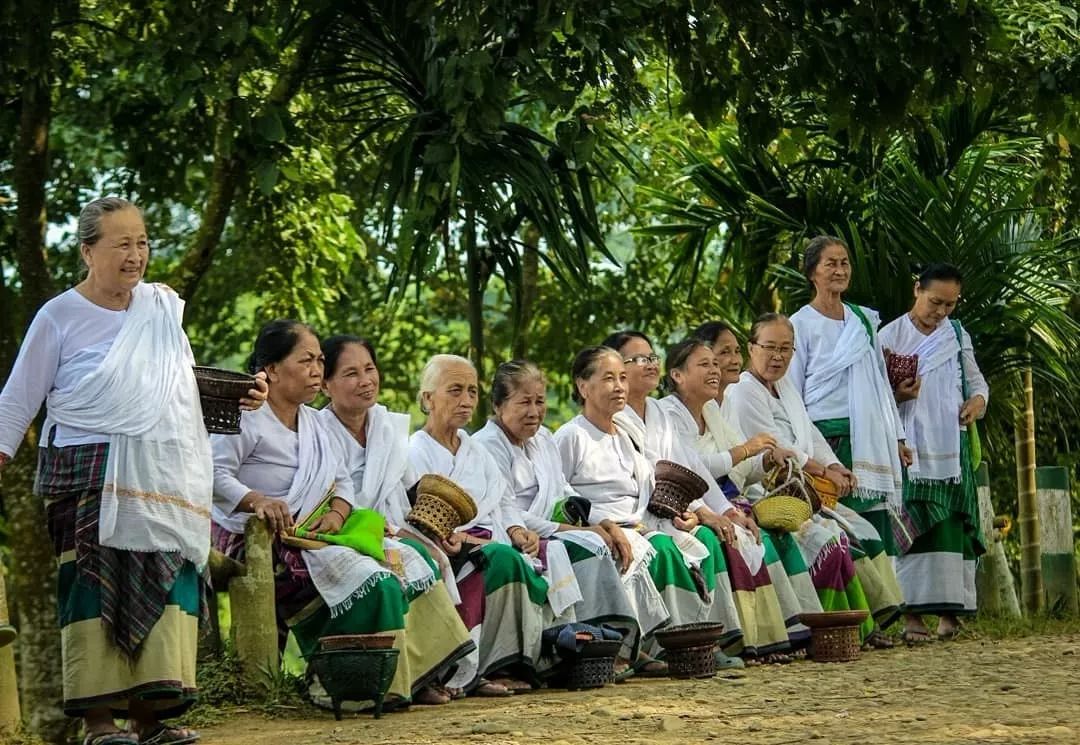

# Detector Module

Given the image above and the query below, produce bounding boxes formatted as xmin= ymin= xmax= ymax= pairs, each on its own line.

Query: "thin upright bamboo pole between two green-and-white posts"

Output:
xmin=1015 ymin=367 xmax=1045 ymax=615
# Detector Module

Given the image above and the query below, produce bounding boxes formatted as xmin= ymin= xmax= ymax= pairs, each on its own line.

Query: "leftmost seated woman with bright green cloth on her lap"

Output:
xmin=213 ymin=321 xmax=471 ymax=705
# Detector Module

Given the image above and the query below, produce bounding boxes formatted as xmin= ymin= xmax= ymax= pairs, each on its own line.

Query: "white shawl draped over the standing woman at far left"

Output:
xmin=48 ymin=283 xmax=214 ymax=567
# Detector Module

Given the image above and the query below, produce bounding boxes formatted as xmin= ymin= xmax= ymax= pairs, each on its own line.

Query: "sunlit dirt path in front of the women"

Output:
xmin=203 ymin=635 xmax=1080 ymax=745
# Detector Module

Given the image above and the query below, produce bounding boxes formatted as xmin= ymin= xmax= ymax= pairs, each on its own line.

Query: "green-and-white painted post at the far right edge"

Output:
xmin=1035 ymin=465 xmax=1080 ymax=615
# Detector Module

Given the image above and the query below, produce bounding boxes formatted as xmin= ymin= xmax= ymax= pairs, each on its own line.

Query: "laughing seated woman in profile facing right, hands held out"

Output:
xmin=660 ymin=330 xmax=821 ymax=662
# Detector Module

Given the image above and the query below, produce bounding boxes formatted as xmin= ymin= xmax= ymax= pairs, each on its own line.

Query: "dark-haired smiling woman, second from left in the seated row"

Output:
xmin=319 ymin=335 xmax=475 ymax=704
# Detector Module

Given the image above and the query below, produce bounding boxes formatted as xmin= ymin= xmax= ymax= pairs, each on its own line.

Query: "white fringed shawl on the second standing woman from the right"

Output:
xmin=804 ymin=306 xmax=903 ymax=512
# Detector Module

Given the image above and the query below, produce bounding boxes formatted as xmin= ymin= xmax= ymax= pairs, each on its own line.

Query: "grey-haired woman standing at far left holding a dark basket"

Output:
xmin=0 ymin=197 xmax=266 ymax=745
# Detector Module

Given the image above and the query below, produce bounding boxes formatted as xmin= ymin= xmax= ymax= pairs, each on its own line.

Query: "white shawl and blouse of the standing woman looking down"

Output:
xmin=880 ymin=313 xmax=963 ymax=483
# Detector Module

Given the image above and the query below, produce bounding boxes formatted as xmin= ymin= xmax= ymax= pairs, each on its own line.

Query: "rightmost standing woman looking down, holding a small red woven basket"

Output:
xmin=881 ymin=265 xmax=990 ymax=641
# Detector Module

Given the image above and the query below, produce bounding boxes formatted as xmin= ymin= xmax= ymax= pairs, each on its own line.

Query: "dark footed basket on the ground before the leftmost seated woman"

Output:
xmin=308 ymin=649 xmax=400 ymax=719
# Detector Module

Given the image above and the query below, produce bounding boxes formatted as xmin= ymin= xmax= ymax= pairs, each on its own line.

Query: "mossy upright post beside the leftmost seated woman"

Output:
xmin=229 ymin=518 xmax=279 ymax=688
